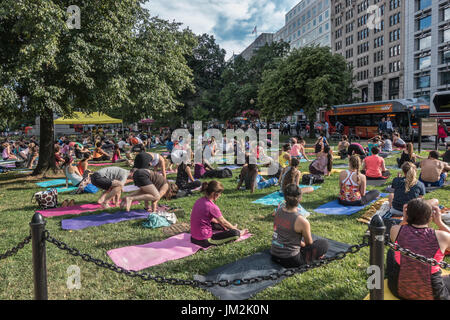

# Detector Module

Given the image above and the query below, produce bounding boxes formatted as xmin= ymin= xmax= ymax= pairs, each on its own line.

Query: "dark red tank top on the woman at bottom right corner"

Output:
xmin=395 ymin=225 xmax=444 ymax=300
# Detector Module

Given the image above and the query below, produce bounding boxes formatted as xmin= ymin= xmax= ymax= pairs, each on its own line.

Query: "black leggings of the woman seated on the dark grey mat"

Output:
xmin=272 ymin=239 xmax=328 ymax=268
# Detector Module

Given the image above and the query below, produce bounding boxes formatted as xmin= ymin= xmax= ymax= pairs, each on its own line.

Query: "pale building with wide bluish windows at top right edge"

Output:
xmin=404 ymin=0 xmax=450 ymax=101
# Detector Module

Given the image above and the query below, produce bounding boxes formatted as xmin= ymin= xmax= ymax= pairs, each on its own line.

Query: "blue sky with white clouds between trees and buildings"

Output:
xmin=146 ymin=0 xmax=300 ymax=59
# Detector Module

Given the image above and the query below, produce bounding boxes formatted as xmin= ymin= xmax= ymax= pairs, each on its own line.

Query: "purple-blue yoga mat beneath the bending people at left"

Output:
xmin=61 ymin=210 xmax=149 ymax=230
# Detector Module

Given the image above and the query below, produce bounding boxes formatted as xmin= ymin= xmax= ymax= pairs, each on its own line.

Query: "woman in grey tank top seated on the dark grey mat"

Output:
xmin=270 ymin=184 xmax=328 ymax=268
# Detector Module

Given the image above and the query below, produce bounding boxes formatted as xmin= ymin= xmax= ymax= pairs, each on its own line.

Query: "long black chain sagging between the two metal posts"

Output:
xmin=44 ymin=230 xmax=369 ymax=288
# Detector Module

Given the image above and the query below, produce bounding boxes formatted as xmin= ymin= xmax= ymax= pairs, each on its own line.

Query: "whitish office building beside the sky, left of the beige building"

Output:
xmin=274 ymin=0 xmax=331 ymax=48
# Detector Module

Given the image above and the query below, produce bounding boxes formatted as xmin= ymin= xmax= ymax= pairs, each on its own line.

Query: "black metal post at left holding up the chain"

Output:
xmin=30 ymin=213 xmax=48 ymax=300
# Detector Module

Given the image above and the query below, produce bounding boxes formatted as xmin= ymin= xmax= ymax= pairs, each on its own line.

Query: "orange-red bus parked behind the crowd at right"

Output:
xmin=320 ymin=99 xmax=430 ymax=141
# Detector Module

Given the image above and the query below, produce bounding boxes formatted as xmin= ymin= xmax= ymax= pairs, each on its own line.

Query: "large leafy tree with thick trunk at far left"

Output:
xmin=0 ymin=0 xmax=196 ymax=174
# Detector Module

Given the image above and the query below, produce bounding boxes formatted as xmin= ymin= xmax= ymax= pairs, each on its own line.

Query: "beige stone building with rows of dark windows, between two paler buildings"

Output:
xmin=331 ymin=0 xmax=404 ymax=102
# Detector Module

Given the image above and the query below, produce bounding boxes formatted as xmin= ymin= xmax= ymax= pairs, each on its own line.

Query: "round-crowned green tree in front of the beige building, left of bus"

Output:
xmin=258 ymin=47 xmax=353 ymax=134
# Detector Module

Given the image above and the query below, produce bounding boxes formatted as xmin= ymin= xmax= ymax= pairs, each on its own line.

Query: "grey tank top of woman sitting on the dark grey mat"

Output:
xmin=270 ymin=208 xmax=303 ymax=259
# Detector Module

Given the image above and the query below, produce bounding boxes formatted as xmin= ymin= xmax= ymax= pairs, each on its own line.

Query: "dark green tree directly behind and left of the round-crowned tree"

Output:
xmin=220 ymin=42 xmax=289 ymax=119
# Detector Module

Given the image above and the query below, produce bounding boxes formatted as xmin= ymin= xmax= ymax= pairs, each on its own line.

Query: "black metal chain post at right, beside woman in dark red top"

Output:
xmin=369 ymin=215 xmax=386 ymax=300
